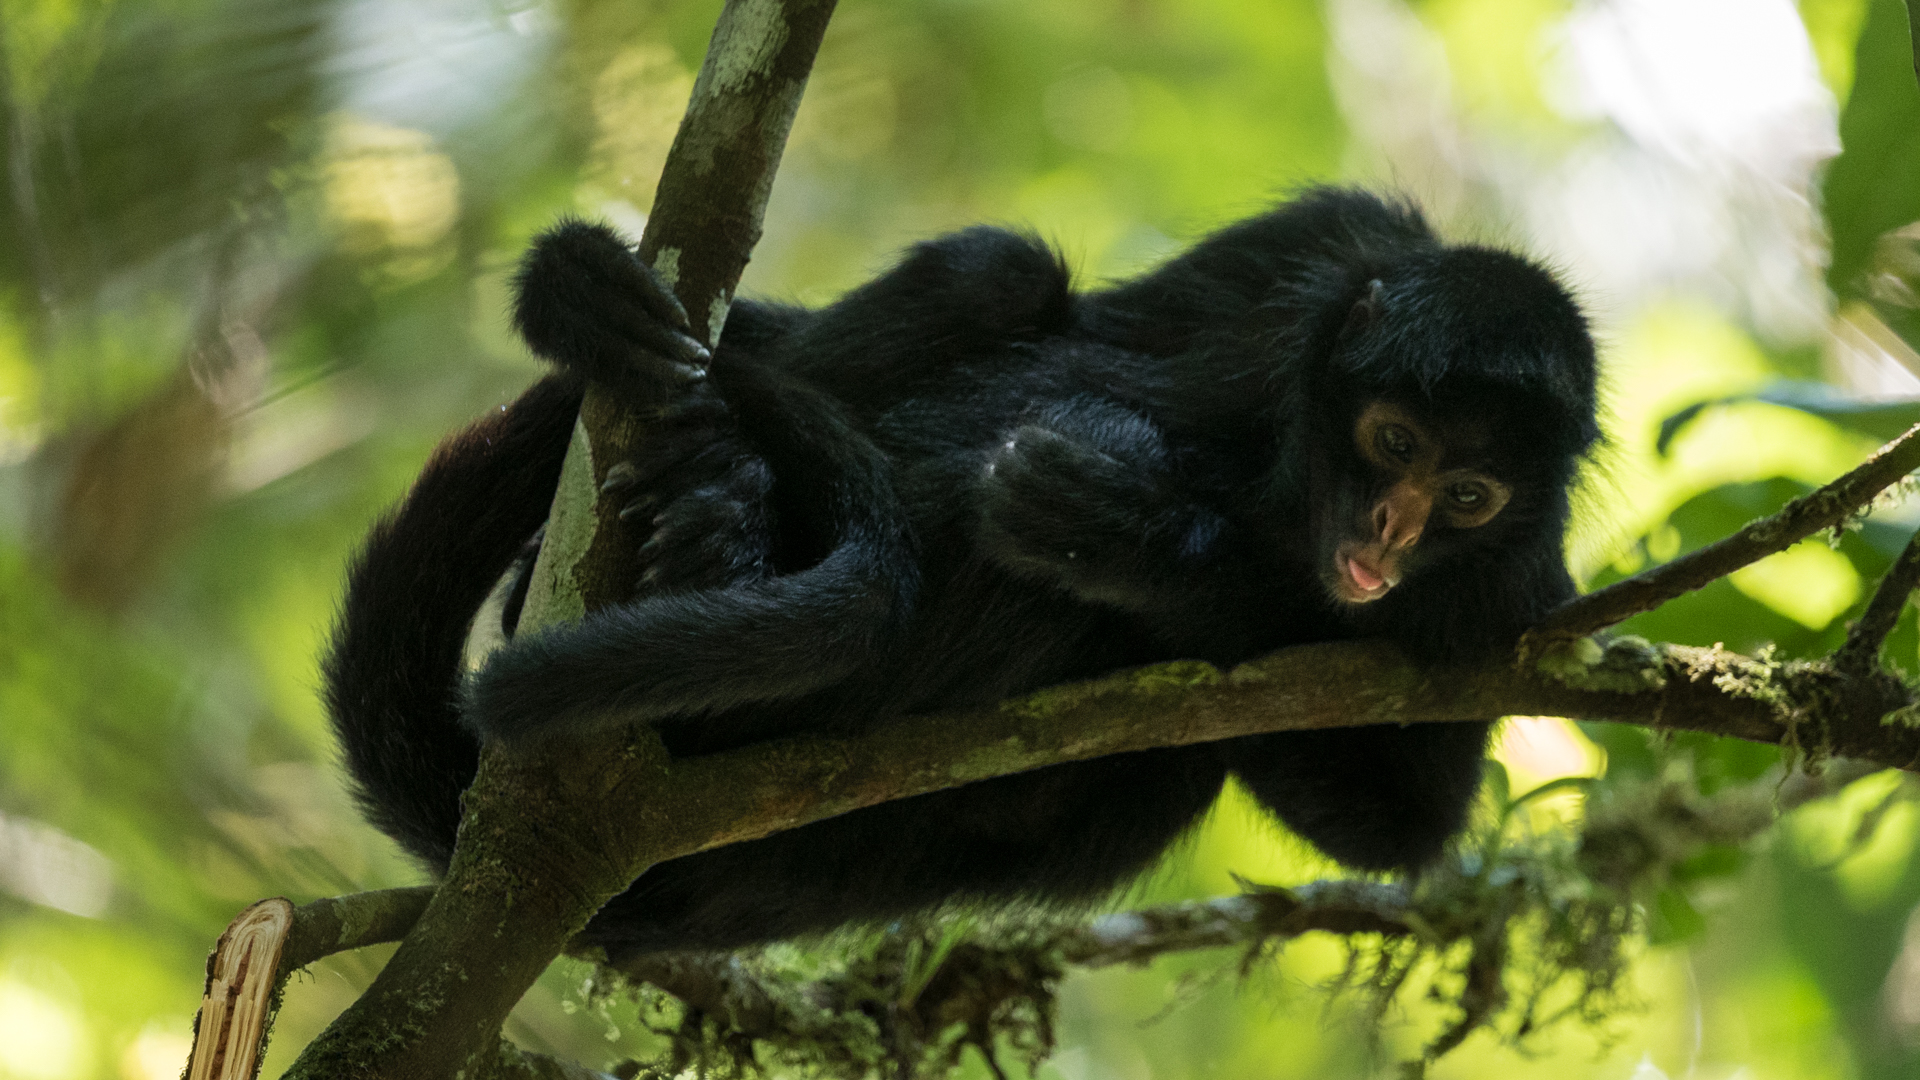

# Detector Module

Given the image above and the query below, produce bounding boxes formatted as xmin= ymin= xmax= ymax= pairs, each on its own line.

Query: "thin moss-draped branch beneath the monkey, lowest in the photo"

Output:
xmin=595 ymin=765 xmax=1860 ymax=1076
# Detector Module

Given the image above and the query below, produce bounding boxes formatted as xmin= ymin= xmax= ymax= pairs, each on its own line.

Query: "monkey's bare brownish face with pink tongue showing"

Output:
xmin=1315 ymin=400 xmax=1513 ymax=603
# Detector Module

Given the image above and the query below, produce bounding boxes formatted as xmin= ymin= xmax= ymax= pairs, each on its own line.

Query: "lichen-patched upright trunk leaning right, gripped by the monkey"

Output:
xmin=276 ymin=0 xmax=833 ymax=1080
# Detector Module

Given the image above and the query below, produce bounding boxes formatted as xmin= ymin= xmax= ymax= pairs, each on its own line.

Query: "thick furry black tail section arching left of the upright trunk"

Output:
xmin=321 ymin=377 xmax=580 ymax=867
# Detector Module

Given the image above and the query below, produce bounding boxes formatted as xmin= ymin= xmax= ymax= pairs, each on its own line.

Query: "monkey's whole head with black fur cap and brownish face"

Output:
xmin=1308 ymin=248 xmax=1599 ymax=605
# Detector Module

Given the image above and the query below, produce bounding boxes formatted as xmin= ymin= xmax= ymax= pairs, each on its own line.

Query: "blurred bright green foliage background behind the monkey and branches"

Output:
xmin=0 ymin=0 xmax=1920 ymax=1080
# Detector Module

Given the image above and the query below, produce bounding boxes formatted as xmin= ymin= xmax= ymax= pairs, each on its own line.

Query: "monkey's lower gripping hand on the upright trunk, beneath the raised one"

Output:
xmin=605 ymin=386 xmax=776 ymax=594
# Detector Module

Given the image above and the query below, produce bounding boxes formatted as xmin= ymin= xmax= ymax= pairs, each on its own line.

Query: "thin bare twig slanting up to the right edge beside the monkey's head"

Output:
xmin=1519 ymin=420 xmax=1920 ymax=663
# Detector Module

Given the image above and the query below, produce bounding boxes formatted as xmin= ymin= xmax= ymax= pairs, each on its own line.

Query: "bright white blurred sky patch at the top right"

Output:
xmin=1517 ymin=0 xmax=1839 ymax=340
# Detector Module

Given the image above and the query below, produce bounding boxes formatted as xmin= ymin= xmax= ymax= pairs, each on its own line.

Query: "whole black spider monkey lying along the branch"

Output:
xmin=324 ymin=188 xmax=1597 ymax=957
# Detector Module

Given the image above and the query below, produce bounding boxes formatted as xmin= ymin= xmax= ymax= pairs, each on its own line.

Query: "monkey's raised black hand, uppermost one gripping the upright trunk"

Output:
xmin=513 ymin=221 xmax=710 ymax=386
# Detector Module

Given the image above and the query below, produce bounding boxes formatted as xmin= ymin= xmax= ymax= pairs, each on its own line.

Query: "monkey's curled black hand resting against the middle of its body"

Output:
xmin=975 ymin=417 xmax=1225 ymax=611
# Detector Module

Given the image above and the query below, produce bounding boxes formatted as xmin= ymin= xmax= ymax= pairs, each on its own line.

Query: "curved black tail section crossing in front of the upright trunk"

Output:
xmin=463 ymin=361 xmax=920 ymax=740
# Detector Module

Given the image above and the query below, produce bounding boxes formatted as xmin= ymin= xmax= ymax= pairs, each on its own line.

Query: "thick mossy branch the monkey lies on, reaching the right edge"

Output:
xmin=270 ymin=640 xmax=1920 ymax=970
